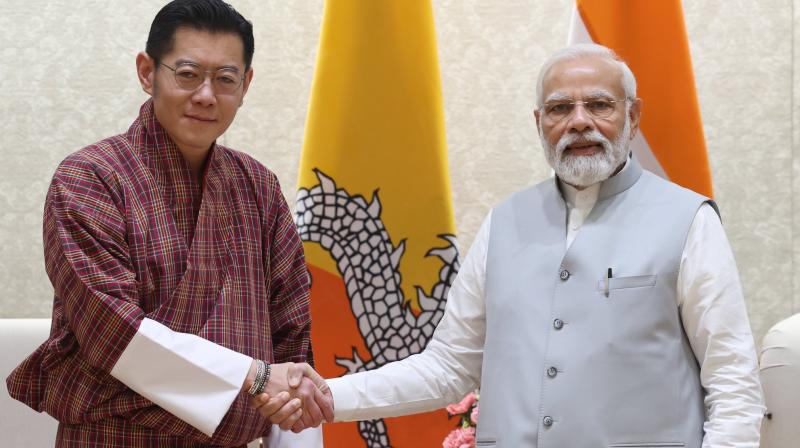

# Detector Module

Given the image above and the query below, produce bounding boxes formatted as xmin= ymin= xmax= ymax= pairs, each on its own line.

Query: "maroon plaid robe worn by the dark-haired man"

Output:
xmin=7 ymin=100 xmax=311 ymax=448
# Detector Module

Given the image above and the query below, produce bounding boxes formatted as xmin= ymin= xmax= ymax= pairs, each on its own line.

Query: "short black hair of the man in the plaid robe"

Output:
xmin=145 ymin=0 xmax=255 ymax=70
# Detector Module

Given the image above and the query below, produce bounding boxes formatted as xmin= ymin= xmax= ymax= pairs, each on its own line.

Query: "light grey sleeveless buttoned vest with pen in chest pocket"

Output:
xmin=477 ymin=159 xmax=714 ymax=448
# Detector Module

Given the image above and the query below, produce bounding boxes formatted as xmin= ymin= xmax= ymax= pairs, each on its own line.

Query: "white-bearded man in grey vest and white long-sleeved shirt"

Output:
xmin=255 ymin=45 xmax=763 ymax=448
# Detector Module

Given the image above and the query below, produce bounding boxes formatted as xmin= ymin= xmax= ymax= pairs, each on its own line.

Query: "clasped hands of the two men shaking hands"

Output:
xmin=243 ymin=361 xmax=333 ymax=432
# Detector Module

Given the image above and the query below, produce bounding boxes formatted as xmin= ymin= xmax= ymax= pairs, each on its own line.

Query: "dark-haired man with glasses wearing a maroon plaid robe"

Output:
xmin=7 ymin=0 xmax=332 ymax=448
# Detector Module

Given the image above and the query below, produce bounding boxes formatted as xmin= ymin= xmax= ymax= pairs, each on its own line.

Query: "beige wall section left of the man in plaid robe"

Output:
xmin=0 ymin=0 xmax=156 ymax=317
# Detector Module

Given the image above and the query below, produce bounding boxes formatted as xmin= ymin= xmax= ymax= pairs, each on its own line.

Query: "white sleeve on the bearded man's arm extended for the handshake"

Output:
xmin=328 ymin=213 xmax=491 ymax=421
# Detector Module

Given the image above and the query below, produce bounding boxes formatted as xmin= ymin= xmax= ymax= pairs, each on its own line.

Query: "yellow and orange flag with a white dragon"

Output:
xmin=295 ymin=0 xmax=458 ymax=448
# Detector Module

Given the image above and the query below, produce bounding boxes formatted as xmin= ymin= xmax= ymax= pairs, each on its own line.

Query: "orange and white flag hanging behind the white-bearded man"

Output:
xmin=569 ymin=0 xmax=712 ymax=197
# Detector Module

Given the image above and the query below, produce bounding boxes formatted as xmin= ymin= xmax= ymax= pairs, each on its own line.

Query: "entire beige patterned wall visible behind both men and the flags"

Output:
xmin=0 ymin=0 xmax=800 ymax=344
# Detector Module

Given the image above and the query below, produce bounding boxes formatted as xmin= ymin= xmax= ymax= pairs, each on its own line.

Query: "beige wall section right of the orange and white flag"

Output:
xmin=684 ymin=0 xmax=793 ymax=341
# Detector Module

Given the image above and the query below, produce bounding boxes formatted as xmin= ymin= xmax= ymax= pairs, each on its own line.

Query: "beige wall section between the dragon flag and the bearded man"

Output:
xmin=434 ymin=0 xmax=572 ymax=253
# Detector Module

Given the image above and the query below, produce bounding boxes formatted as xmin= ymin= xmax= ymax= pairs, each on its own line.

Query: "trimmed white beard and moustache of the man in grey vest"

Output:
xmin=539 ymin=118 xmax=631 ymax=188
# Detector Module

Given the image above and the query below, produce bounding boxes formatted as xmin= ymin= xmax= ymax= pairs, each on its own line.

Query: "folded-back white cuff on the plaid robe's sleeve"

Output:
xmin=111 ymin=318 xmax=253 ymax=436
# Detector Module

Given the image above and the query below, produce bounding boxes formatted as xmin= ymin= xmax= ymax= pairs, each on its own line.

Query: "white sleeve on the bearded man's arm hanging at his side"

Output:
xmin=678 ymin=204 xmax=764 ymax=448
